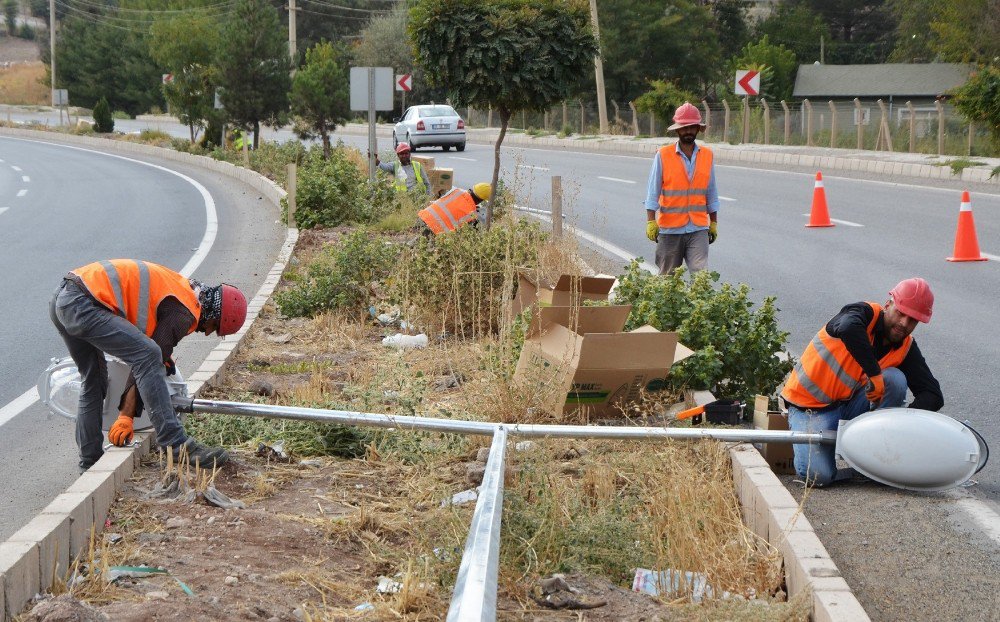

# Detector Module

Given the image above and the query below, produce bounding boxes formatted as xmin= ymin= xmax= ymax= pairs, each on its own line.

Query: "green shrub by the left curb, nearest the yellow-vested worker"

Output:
xmin=295 ymin=145 xmax=398 ymax=229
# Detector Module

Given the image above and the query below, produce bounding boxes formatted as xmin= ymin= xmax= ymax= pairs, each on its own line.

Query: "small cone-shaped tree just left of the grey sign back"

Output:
xmin=289 ymin=42 xmax=351 ymax=159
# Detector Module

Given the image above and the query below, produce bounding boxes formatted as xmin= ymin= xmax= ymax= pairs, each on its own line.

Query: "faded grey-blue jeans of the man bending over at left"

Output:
xmin=49 ymin=280 xmax=187 ymax=467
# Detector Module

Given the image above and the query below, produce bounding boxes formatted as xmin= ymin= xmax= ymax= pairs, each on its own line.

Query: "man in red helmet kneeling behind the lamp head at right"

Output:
xmin=781 ymin=278 xmax=944 ymax=486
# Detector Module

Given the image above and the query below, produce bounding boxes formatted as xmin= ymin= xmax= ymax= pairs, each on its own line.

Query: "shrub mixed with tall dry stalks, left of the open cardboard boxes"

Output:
xmin=389 ymin=218 xmax=547 ymax=336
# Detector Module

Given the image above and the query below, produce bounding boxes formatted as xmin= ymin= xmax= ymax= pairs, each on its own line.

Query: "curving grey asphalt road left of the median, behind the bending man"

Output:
xmin=0 ymin=138 xmax=285 ymax=541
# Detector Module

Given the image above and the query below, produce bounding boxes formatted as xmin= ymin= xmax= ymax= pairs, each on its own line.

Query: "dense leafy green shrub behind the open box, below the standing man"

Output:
xmin=616 ymin=261 xmax=792 ymax=402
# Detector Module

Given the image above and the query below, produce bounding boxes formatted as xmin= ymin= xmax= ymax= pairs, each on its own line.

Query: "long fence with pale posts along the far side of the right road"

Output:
xmin=460 ymin=99 xmax=1000 ymax=156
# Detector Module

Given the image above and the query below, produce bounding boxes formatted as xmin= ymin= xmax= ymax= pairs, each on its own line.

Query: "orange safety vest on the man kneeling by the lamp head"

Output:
xmin=781 ymin=302 xmax=913 ymax=408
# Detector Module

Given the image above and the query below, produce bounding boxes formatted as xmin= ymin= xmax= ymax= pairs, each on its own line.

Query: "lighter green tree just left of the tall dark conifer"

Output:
xmin=150 ymin=15 xmax=218 ymax=144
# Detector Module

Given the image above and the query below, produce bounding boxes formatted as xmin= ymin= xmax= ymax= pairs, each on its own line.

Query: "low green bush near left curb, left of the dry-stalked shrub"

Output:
xmin=276 ymin=229 xmax=398 ymax=317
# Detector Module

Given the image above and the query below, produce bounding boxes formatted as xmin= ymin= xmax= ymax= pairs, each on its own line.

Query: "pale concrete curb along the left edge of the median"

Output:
xmin=0 ymin=129 xmax=298 ymax=622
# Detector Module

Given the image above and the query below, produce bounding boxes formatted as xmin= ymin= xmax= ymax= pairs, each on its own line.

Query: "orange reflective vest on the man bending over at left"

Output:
xmin=72 ymin=259 xmax=201 ymax=337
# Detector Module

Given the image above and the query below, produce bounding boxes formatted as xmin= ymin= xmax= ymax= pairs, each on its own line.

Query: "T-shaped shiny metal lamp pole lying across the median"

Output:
xmin=172 ymin=396 xmax=836 ymax=622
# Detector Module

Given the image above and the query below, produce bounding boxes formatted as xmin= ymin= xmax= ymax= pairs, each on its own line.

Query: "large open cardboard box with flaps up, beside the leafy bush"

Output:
xmin=514 ymin=306 xmax=693 ymax=418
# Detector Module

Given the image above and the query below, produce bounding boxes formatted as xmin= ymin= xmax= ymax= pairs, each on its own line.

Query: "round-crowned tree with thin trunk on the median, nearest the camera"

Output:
xmin=410 ymin=0 xmax=597 ymax=227
